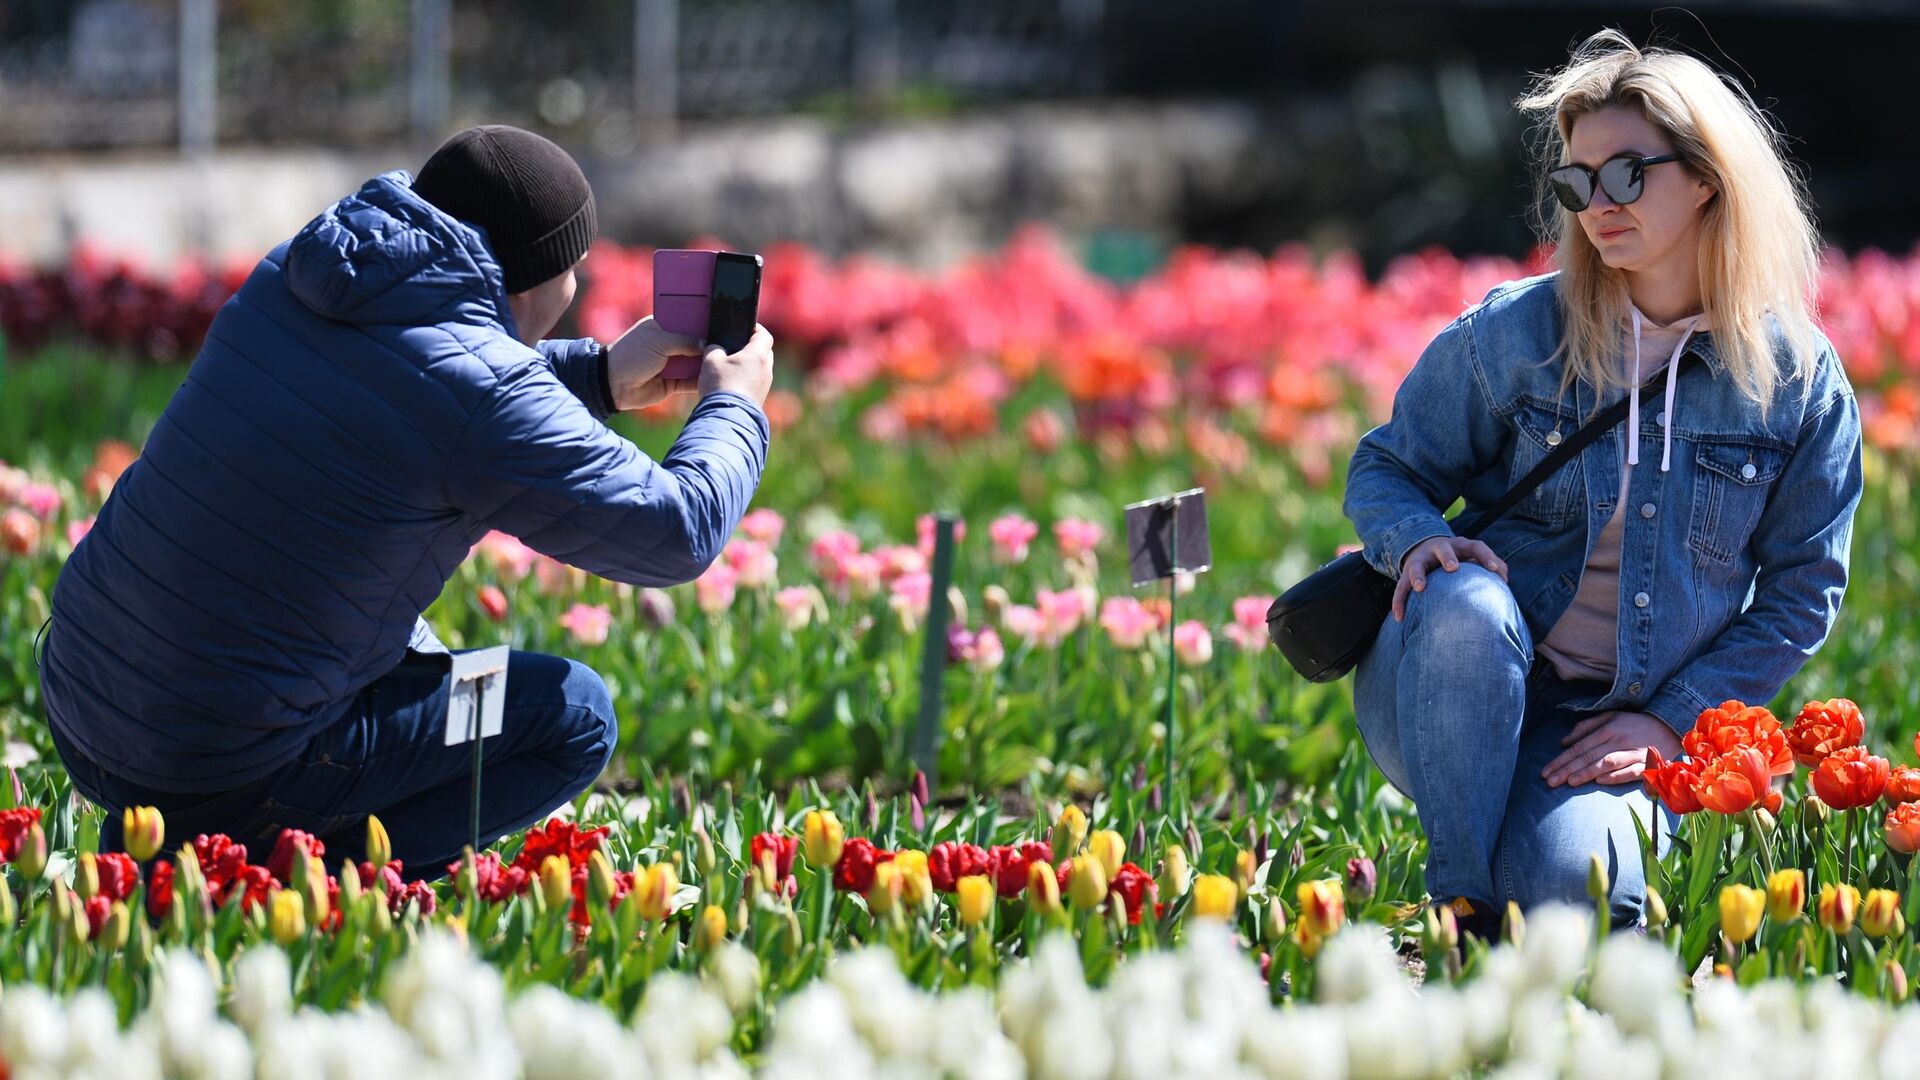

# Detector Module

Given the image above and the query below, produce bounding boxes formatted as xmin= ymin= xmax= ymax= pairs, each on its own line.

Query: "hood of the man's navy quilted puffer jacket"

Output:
xmin=284 ymin=169 xmax=513 ymax=332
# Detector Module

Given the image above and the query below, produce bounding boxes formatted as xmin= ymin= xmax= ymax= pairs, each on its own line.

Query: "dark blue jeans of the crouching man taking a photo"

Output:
xmin=54 ymin=651 xmax=618 ymax=880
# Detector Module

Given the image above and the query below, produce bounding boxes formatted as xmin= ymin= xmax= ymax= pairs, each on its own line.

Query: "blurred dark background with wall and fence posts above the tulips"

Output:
xmin=0 ymin=0 xmax=1920 ymax=272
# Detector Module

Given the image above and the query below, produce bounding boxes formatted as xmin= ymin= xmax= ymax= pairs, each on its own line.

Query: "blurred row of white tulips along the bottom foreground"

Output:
xmin=0 ymin=909 xmax=1920 ymax=1080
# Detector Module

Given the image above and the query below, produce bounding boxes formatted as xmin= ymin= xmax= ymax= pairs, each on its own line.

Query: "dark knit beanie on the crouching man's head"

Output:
xmin=413 ymin=123 xmax=595 ymax=292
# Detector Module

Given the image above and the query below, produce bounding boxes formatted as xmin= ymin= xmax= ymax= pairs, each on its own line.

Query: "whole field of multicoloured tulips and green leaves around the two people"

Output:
xmin=0 ymin=231 xmax=1920 ymax=1078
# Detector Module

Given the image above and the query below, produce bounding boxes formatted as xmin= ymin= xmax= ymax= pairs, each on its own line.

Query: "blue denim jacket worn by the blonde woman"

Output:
xmin=1344 ymin=275 xmax=1860 ymax=732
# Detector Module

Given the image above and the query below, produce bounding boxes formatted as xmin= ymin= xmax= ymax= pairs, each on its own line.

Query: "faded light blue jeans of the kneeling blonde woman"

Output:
xmin=1354 ymin=563 xmax=1674 ymax=926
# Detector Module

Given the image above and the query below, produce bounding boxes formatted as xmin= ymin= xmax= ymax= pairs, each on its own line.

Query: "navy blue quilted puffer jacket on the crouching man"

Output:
xmin=40 ymin=171 xmax=768 ymax=794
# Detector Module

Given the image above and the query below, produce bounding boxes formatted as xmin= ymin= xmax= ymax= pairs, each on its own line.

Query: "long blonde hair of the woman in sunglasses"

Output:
xmin=1515 ymin=31 xmax=1820 ymax=415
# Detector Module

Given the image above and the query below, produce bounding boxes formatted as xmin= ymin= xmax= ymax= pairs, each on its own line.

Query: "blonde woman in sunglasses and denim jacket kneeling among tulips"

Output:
xmin=1344 ymin=31 xmax=1860 ymax=936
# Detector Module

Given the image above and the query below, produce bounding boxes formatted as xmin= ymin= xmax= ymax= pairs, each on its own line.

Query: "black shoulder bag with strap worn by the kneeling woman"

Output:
xmin=1267 ymin=352 xmax=1699 ymax=682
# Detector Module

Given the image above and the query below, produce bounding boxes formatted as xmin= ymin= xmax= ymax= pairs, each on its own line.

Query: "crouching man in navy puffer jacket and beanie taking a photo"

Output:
xmin=40 ymin=127 xmax=774 ymax=876
